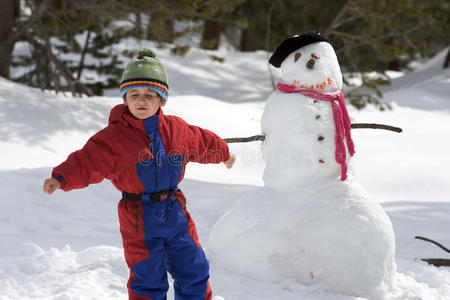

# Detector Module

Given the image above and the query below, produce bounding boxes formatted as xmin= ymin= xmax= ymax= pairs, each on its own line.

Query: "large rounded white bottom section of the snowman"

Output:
xmin=208 ymin=180 xmax=396 ymax=299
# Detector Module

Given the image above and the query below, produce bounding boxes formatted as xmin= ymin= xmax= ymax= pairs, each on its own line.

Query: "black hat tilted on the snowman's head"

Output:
xmin=269 ymin=31 xmax=330 ymax=68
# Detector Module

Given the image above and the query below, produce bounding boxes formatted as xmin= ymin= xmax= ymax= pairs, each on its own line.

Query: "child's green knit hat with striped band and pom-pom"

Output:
xmin=120 ymin=48 xmax=169 ymax=100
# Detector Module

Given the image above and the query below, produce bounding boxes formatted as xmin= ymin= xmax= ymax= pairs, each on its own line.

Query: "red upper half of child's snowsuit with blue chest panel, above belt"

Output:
xmin=52 ymin=104 xmax=229 ymax=194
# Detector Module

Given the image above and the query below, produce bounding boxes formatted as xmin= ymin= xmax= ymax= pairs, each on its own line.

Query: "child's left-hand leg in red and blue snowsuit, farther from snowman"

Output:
xmin=118 ymin=200 xmax=169 ymax=300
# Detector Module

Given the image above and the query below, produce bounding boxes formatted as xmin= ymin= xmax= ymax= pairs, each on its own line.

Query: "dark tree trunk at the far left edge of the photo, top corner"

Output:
xmin=0 ymin=0 xmax=19 ymax=79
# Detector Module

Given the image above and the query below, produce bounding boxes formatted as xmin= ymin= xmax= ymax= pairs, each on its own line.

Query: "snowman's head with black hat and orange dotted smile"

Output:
xmin=269 ymin=32 xmax=342 ymax=92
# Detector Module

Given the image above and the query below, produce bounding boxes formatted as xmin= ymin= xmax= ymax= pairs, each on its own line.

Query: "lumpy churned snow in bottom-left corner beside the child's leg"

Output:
xmin=0 ymin=243 xmax=127 ymax=300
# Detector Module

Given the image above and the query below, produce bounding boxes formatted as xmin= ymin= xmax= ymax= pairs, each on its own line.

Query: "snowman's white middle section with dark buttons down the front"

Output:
xmin=261 ymin=91 xmax=344 ymax=188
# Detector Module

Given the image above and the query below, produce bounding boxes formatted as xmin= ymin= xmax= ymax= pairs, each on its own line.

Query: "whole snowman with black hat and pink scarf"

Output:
xmin=208 ymin=32 xmax=396 ymax=299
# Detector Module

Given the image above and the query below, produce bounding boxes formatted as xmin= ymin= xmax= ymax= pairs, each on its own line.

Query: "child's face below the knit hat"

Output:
xmin=123 ymin=87 xmax=163 ymax=120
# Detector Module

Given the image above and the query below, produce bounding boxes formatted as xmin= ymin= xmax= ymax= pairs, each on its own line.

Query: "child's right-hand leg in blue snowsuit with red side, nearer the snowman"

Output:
xmin=165 ymin=201 xmax=212 ymax=300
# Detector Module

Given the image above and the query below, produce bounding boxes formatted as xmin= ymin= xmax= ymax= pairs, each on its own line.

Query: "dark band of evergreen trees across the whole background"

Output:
xmin=0 ymin=0 xmax=450 ymax=108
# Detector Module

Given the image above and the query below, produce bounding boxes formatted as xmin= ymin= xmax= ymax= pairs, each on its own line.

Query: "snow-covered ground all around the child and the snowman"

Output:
xmin=0 ymin=45 xmax=450 ymax=300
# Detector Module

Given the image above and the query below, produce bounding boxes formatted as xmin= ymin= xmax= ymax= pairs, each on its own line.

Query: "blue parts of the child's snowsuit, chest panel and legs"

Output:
xmin=130 ymin=116 xmax=209 ymax=300
